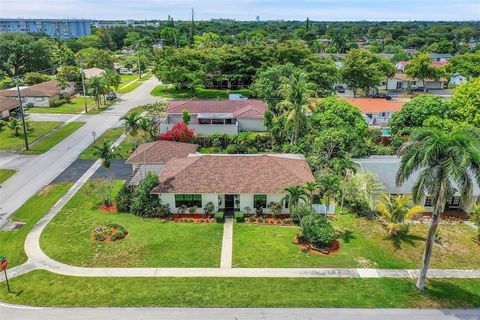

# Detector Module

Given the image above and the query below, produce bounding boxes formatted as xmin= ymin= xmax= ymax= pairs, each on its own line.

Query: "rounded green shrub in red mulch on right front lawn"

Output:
xmin=299 ymin=214 xmax=335 ymax=249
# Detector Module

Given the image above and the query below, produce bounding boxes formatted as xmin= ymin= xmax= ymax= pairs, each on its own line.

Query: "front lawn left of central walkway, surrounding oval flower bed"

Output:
xmin=40 ymin=181 xmax=223 ymax=267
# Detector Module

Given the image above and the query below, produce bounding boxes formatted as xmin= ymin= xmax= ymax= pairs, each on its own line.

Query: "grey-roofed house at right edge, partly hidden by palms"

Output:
xmin=353 ymin=156 xmax=480 ymax=212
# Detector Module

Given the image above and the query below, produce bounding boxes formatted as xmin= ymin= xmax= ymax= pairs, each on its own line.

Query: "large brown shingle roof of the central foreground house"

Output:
xmin=152 ymin=155 xmax=314 ymax=194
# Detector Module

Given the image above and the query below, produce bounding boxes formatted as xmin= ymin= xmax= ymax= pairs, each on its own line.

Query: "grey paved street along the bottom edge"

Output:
xmin=0 ymin=303 xmax=480 ymax=320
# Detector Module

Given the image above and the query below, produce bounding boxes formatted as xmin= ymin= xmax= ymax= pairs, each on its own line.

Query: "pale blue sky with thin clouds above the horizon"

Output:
xmin=0 ymin=0 xmax=480 ymax=21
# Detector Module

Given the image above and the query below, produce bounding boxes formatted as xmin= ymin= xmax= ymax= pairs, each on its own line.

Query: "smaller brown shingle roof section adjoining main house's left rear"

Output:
xmin=127 ymin=140 xmax=198 ymax=164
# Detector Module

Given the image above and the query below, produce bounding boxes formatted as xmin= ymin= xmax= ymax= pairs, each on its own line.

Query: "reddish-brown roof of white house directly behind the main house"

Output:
xmin=167 ymin=99 xmax=267 ymax=118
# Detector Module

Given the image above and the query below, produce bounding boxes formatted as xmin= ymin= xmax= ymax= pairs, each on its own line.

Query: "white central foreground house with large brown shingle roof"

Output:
xmin=151 ymin=154 xmax=315 ymax=213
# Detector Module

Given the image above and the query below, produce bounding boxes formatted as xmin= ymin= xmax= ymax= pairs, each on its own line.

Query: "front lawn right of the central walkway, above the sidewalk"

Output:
xmin=233 ymin=215 xmax=480 ymax=269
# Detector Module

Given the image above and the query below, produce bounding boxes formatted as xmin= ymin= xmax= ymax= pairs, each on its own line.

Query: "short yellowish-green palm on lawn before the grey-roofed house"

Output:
xmin=375 ymin=194 xmax=425 ymax=235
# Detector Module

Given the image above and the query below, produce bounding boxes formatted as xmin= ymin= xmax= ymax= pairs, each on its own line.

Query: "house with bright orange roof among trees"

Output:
xmin=344 ymin=98 xmax=405 ymax=126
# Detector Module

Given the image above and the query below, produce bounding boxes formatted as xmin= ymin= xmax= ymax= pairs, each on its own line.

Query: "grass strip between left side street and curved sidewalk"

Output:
xmin=0 ymin=183 xmax=72 ymax=267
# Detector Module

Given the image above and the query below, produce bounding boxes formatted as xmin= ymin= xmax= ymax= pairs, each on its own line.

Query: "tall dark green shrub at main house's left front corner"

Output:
xmin=130 ymin=172 xmax=162 ymax=217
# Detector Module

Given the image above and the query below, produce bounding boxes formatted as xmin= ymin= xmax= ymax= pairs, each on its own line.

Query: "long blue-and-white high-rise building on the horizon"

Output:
xmin=0 ymin=18 xmax=92 ymax=39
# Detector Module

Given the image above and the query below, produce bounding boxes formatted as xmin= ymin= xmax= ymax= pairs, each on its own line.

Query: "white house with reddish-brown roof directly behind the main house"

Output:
xmin=160 ymin=99 xmax=267 ymax=135
